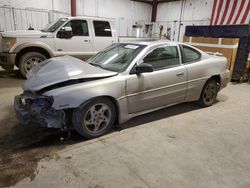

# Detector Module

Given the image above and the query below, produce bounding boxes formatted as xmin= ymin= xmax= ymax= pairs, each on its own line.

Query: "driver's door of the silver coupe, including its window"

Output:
xmin=126 ymin=46 xmax=187 ymax=114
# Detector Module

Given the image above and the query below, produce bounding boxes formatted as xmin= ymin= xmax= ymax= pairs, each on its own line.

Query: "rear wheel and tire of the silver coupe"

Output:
xmin=198 ymin=79 xmax=219 ymax=107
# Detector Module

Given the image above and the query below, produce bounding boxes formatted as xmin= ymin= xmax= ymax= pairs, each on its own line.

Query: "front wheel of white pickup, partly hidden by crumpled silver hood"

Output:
xmin=19 ymin=52 xmax=46 ymax=78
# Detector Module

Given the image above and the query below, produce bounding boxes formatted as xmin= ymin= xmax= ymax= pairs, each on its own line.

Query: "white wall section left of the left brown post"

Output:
xmin=0 ymin=0 xmax=70 ymax=31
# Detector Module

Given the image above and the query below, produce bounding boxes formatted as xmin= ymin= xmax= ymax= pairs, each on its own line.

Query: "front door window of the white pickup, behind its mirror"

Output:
xmin=64 ymin=20 xmax=89 ymax=36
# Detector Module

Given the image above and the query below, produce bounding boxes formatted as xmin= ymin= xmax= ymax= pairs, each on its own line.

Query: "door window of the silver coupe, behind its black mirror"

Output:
xmin=143 ymin=46 xmax=180 ymax=70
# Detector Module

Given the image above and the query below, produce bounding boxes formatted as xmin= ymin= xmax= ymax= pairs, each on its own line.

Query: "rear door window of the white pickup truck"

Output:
xmin=93 ymin=21 xmax=112 ymax=37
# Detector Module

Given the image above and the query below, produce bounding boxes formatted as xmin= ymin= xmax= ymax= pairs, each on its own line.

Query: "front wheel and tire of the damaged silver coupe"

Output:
xmin=72 ymin=98 xmax=116 ymax=138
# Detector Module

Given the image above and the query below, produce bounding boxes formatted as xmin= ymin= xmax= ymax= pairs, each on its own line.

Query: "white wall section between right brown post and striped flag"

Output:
xmin=157 ymin=0 xmax=214 ymax=41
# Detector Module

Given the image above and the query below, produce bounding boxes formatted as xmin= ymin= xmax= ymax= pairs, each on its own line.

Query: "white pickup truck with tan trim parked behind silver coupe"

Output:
xmin=0 ymin=17 xmax=153 ymax=77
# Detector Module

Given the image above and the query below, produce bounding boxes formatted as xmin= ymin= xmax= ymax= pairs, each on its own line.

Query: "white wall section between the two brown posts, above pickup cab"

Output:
xmin=77 ymin=0 xmax=152 ymax=36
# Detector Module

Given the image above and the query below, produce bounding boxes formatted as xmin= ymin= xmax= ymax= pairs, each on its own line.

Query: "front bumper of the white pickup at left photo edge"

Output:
xmin=0 ymin=53 xmax=16 ymax=70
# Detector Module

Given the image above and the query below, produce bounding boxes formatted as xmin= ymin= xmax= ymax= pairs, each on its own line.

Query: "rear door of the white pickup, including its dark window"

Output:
xmin=92 ymin=20 xmax=115 ymax=53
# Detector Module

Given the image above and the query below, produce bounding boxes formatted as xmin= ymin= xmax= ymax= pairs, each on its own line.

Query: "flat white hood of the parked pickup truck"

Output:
xmin=2 ymin=30 xmax=53 ymax=38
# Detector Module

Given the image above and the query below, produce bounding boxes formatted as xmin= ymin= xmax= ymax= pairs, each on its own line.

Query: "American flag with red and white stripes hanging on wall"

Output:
xmin=210 ymin=0 xmax=250 ymax=25
